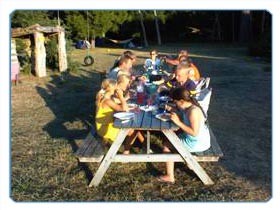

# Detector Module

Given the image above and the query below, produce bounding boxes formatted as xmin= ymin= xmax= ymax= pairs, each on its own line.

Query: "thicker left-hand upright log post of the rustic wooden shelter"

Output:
xmin=34 ymin=31 xmax=47 ymax=77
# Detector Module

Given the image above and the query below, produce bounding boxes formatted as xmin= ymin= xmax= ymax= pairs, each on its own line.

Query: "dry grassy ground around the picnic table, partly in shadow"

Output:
xmin=11 ymin=45 xmax=272 ymax=201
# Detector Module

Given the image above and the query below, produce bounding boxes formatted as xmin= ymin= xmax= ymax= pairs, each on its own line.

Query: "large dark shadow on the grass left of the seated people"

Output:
xmin=36 ymin=71 xmax=102 ymax=145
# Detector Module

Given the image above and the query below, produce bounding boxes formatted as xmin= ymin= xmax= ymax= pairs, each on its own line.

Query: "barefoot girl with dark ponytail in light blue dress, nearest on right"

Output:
xmin=159 ymin=87 xmax=210 ymax=183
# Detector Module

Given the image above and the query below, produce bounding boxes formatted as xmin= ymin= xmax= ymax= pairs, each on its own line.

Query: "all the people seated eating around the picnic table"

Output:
xmin=95 ymin=50 xmax=210 ymax=183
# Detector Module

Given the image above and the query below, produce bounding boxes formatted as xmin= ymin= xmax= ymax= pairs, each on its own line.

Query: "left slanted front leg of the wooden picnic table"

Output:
xmin=89 ymin=129 xmax=129 ymax=187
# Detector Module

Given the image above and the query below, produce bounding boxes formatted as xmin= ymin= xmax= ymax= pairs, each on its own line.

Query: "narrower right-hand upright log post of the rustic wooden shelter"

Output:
xmin=57 ymin=28 xmax=67 ymax=72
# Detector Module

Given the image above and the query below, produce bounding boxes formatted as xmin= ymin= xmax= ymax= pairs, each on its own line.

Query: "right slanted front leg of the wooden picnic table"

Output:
xmin=162 ymin=130 xmax=214 ymax=185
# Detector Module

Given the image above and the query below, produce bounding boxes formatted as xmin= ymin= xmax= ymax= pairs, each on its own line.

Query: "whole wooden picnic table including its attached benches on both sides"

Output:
xmin=76 ymin=80 xmax=223 ymax=187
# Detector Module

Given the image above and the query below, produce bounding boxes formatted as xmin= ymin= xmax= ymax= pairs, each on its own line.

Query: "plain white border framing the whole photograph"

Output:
xmin=0 ymin=0 xmax=280 ymax=210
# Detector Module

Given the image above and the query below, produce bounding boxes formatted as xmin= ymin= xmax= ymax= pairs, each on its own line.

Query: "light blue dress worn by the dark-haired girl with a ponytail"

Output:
xmin=178 ymin=107 xmax=210 ymax=152
